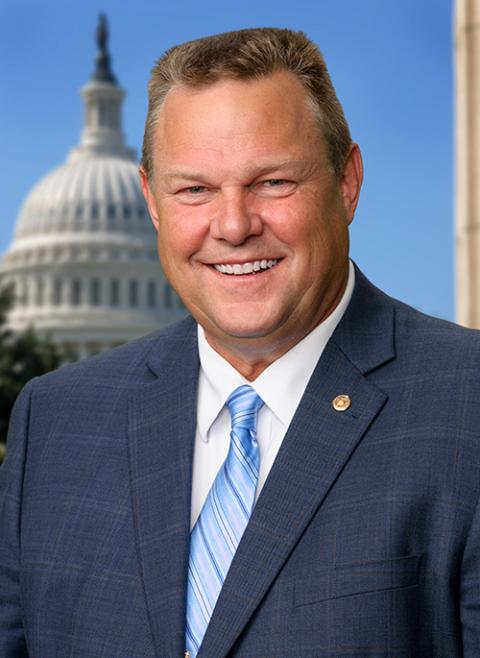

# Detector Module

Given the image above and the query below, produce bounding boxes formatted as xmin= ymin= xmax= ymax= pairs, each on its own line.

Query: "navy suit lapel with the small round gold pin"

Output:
xmin=198 ymin=271 xmax=394 ymax=658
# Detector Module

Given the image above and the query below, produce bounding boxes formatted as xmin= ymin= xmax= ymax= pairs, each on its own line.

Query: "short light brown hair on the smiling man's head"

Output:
xmin=141 ymin=28 xmax=352 ymax=180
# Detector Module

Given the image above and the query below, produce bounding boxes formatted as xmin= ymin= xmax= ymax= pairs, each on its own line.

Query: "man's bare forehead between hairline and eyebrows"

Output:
xmin=154 ymin=71 xmax=319 ymax=169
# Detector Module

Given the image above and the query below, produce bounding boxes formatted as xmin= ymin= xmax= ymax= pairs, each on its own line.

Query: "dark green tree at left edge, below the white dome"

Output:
xmin=0 ymin=287 xmax=63 ymax=463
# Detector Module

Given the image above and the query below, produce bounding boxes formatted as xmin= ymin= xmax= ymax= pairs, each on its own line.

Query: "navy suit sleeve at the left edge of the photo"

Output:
xmin=0 ymin=382 xmax=32 ymax=658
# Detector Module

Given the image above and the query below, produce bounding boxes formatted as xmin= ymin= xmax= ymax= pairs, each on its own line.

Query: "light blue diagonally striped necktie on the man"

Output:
xmin=185 ymin=385 xmax=263 ymax=658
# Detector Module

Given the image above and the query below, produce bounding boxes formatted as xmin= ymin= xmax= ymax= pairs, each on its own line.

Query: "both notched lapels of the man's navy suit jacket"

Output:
xmin=129 ymin=269 xmax=395 ymax=658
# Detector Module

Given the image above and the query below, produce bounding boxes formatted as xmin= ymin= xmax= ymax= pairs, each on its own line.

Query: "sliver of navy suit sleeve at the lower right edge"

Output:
xmin=460 ymin=486 xmax=480 ymax=658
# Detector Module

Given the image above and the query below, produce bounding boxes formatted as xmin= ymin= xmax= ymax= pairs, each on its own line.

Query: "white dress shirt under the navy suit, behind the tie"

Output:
xmin=191 ymin=262 xmax=355 ymax=528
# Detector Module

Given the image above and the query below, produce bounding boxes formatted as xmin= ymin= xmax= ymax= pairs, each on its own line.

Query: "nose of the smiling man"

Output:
xmin=210 ymin=187 xmax=263 ymax=245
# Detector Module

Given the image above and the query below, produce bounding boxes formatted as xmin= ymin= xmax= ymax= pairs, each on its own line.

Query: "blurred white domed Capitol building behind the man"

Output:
xmin=0 ymin=17 xmax=186 ymax=358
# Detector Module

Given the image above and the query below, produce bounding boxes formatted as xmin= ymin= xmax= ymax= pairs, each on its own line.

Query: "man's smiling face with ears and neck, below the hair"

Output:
xmin=142 ymin=71 xmax=361 ymax=368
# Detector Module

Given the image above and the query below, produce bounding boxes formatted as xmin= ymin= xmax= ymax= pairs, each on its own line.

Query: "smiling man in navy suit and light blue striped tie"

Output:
xmin=0 ymin=29 xmax=480 ymax=658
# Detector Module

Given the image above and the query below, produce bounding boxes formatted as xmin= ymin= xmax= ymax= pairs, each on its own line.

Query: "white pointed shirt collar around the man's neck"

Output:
xmin=197 ymin=261 xmax=355 ymax=441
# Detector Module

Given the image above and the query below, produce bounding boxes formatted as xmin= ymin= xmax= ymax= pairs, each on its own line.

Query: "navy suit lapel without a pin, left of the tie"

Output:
xmin=129 ymin=321 xmax=198 ymax=656
